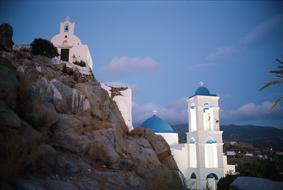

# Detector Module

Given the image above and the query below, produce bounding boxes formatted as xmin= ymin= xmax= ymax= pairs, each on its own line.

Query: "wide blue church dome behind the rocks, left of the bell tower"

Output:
xmin=142 ymin=115 xmax=173 ymax=133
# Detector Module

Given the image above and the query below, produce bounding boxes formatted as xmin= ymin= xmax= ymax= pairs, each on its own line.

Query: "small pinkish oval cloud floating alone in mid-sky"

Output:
xmin=103 ymin=56 xmax=159 ymax=75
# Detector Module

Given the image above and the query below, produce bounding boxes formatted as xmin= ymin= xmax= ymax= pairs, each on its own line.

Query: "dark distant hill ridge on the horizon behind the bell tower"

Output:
xmin=172 ymin=124 xmax=283 ymax=151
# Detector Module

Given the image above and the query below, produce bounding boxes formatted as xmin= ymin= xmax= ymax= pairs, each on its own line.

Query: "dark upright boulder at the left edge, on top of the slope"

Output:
xmin=0 ymin=23 xmax=14 ymax=51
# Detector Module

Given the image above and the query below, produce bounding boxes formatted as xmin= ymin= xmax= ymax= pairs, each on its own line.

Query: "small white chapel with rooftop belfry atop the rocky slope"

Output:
xmin=51 ymin=17 xmax=93 ymax=69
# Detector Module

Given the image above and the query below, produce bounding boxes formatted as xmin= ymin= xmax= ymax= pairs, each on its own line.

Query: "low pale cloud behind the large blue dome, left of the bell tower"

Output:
xmin=133 ymin=99 xmax=188 ymax=126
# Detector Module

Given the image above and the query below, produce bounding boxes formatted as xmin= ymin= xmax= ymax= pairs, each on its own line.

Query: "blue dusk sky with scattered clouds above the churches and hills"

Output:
xmin=0 ymin=0 xmax=283 ymax=128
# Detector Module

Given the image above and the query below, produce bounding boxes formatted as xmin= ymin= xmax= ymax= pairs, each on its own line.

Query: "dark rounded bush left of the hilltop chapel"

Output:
xmin=31 ymin=38 xmax=59 ymax=58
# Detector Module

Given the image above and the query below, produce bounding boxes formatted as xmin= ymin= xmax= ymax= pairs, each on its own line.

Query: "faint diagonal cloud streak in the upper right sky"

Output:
xmin=240 ymin=15 xmax=283 ymax=45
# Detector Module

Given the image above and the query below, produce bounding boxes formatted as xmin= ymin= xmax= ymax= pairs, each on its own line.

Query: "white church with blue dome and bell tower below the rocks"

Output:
xmin=142 ymin=86 xmax=235 ymax=190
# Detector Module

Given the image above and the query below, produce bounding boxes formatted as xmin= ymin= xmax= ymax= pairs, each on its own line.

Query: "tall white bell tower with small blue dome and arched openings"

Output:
xmin=187 ymin=82 xmax=225 ymax=189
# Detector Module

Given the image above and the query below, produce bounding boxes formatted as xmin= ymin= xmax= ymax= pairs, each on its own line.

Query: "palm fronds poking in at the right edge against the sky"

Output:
xmin=259 ymin=59 xmax=283 ymax=110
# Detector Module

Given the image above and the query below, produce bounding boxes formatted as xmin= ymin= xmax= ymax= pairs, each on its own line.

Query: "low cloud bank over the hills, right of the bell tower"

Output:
xmin=221 ymin=101 xmax=283 ymax=127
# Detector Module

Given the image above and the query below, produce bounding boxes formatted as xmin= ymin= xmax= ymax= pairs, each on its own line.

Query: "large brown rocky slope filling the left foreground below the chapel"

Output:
xmin=0 ymin=26 xmax=185 ymax=190
